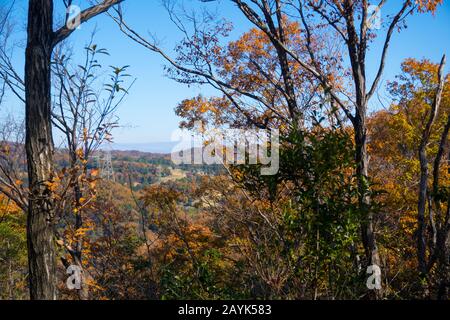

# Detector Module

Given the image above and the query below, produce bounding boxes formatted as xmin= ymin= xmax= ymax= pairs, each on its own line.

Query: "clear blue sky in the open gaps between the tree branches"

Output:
xmin=0 ymin=0 xmax=450 ymax=149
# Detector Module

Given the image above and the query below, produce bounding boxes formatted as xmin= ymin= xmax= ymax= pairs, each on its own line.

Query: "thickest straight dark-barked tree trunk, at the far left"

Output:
xmin=25 ymin=0 xmax=57 ymax=300
